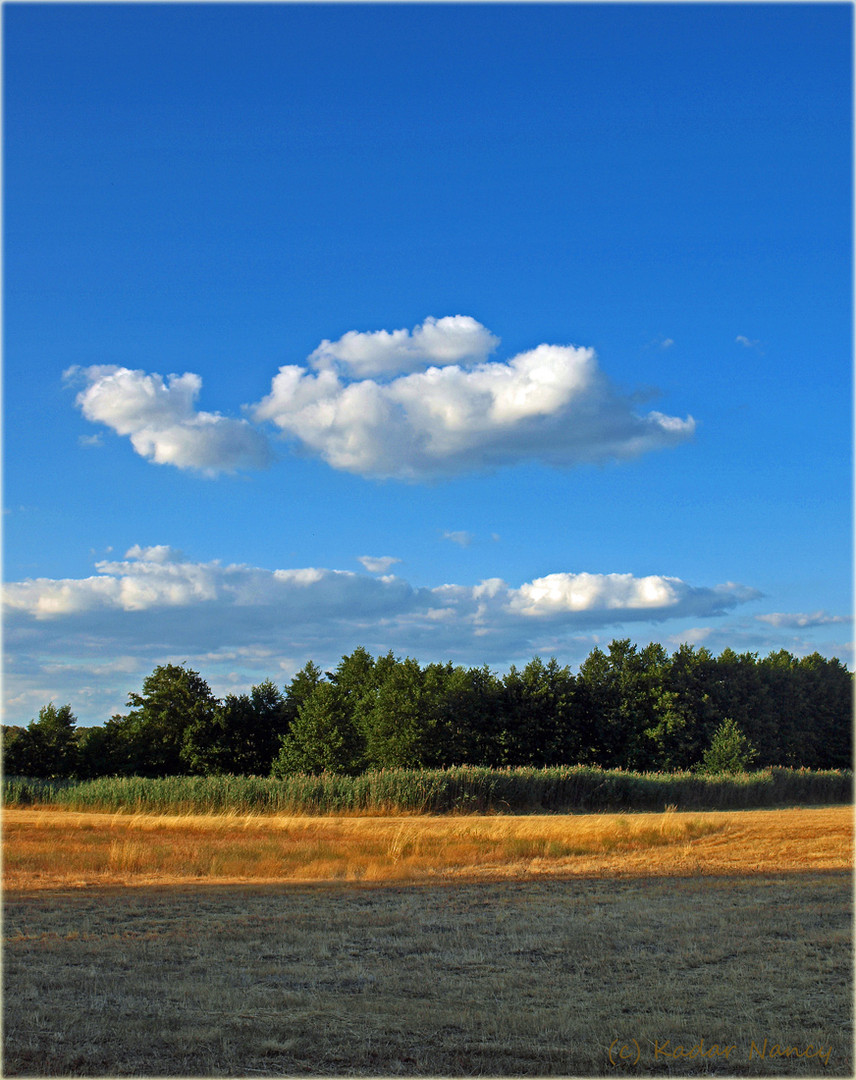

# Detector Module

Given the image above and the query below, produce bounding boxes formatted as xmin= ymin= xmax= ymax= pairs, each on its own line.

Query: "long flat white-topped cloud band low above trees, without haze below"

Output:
xmin=3 ymin=544 xmax=760 ymax=633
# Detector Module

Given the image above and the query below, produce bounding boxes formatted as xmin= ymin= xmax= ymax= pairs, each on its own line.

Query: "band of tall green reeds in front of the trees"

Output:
xmin=3 ymin=766 xmax=853 ymax=814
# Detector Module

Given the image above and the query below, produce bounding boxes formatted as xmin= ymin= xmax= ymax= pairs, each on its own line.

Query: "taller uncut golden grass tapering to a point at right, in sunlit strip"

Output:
xmin=4 ymin=810 xmax=726 ymax=886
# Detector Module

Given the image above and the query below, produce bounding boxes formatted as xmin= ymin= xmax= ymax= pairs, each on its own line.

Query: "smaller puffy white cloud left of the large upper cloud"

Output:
xmin=65 ymin=365 xmax=272 ymax=475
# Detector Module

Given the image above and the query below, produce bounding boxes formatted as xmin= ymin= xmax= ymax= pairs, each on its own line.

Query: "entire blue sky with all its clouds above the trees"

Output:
xmin=3 ymin=3 xmax=852 ymax=724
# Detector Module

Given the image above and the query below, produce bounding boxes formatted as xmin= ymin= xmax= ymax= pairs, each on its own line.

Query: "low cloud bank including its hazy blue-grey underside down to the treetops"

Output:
xmin=4 ymin=545 xmax=758 ymax=723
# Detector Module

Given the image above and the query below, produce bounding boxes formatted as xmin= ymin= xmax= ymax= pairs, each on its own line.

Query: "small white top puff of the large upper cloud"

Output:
xmin=309 ymin=315 xmax=499 ymax=379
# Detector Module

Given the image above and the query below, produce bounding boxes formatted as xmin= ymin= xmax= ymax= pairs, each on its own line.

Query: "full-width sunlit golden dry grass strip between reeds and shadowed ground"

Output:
xmin=3 ymin=807 xmax=853 ymax=890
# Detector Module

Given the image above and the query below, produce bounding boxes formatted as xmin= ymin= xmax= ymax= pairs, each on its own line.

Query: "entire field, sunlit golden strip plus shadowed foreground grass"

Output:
xmin=3 ymin=807 xmax=853 ymax=1077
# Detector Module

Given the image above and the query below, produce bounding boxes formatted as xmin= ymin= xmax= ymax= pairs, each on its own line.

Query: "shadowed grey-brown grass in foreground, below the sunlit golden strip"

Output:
xmin=3 ymin=872 xmax=853 ymax=1077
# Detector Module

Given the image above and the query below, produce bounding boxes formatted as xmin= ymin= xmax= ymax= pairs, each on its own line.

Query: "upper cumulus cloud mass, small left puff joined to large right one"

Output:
xmin=67 ymin=315 xmax=695 ymax=481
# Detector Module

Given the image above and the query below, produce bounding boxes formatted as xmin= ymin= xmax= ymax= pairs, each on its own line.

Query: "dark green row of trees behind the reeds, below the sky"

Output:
xmin=2 ymin=638 xmax=853 ymax=779
